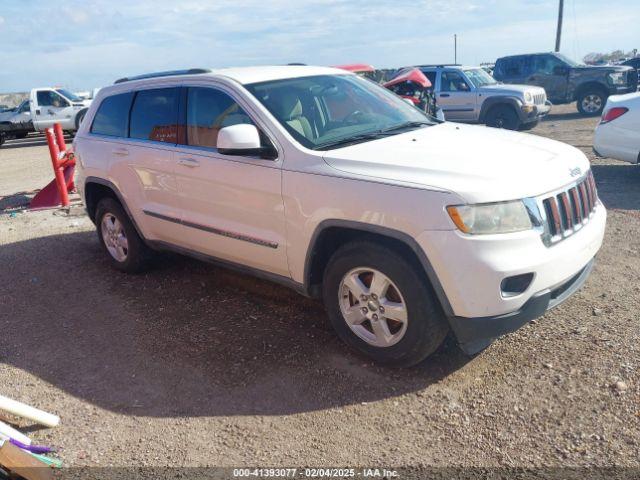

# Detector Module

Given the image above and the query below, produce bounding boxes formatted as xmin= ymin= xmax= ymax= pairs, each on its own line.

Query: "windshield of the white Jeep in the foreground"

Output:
xmin=246 ymin=75 xmax=437 ymax=150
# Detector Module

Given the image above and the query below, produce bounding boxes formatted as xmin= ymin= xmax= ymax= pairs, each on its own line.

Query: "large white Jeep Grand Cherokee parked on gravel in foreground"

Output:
xmin=74 ymin=66 xmax=606 ymax=365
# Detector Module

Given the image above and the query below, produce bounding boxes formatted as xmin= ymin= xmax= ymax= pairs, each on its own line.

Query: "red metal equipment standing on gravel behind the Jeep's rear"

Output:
xmin=29 ymin=123 xmax=76 ymax=209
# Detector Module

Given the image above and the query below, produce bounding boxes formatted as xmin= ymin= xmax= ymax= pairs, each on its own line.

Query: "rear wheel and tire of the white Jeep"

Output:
xmin=95 ymin=198 xmax=152 ymax=273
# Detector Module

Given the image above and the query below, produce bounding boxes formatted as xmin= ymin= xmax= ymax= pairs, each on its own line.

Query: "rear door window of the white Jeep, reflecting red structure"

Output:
xmin=129 ymin=87 xmax=178 ymax=143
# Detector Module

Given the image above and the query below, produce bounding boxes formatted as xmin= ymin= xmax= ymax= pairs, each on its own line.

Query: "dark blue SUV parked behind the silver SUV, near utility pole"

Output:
xmin=493 ymin=53 xmax=638 ymax=115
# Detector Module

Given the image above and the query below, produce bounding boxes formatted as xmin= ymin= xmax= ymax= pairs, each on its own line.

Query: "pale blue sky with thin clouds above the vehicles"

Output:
xmin=0 ymin=0 xmax=640 ymax=92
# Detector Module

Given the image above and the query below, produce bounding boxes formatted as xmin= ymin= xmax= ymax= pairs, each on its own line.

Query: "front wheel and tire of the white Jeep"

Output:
xmin=322 ymin=241 xmax=449 ymax=367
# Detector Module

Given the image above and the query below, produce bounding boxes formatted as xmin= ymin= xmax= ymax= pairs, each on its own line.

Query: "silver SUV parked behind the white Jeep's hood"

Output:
xmin=417 ymin=65 xmax=551 ymax=130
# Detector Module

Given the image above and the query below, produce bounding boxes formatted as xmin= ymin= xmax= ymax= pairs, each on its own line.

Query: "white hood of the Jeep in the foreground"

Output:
xmin=324 ymin=122 xmax=589 ymax=203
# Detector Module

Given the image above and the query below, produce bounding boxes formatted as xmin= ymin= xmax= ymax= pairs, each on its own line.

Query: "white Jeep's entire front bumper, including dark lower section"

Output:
xmin=417 ymin=202 xmax=607 ymax=352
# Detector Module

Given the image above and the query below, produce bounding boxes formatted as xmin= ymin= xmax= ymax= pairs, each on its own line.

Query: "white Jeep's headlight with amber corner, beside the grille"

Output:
xmin=447 ymin=200 xmax=533 ymax=235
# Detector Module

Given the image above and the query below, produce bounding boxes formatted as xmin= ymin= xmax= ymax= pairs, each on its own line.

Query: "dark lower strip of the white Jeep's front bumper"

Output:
xmin=449 ymin=259 xmax=595 ymax=355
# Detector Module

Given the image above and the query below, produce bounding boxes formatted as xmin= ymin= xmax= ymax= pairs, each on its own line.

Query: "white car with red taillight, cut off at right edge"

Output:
xmin=593 ymin=92 xmax=640 ymax=164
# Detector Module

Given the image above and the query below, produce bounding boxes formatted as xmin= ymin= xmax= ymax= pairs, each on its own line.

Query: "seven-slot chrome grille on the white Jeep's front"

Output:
xmin=538 ymin=171 xmax=598 ymax=246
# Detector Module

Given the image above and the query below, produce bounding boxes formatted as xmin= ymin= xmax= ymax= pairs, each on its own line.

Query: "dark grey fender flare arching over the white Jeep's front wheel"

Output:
xmin=303 ymin=219 xmax=454 ymax=317
